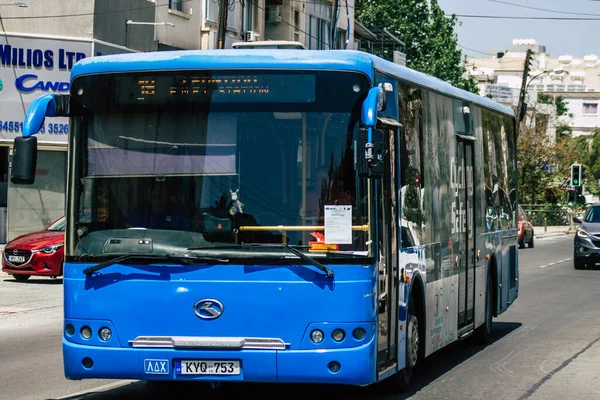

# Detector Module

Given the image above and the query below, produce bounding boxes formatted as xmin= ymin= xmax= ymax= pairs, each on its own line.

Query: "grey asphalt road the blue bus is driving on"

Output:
xmin=0 ymin=235 xmax=600 ymax=400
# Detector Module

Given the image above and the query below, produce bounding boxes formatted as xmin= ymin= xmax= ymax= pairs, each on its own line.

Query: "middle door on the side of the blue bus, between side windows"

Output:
xmin=454 ymin=135 xmax=476 ymax=337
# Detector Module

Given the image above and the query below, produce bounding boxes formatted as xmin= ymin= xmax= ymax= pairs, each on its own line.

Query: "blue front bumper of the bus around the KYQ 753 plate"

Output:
xmin=63 ymin=337 xmax=376 ymax=386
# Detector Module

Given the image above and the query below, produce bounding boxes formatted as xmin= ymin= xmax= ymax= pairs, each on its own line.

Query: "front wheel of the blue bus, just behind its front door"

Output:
xmin=389 ymin=296 xmax=421 ymax=393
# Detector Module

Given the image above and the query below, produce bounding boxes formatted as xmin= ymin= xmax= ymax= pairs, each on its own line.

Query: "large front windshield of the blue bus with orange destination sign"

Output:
xmin=66 ymin=71 xmax=371 ymax=257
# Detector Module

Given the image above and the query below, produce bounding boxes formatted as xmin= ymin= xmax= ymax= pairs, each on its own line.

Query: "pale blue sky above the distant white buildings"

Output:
xmin=438 ymin=0 xmax=600 ymax=58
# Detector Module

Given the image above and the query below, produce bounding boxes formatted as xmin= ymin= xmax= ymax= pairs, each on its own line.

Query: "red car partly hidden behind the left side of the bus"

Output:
xmin=2 ymin=217 xmax=65 ymax=282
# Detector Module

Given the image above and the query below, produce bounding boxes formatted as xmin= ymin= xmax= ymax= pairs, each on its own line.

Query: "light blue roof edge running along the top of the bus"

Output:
xmin=71 ymin=49 xmax=515 ymax=117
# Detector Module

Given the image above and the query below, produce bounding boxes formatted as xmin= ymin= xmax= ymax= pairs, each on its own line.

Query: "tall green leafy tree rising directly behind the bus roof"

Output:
xmin=355 ymin=0 xmax=479 ymax=93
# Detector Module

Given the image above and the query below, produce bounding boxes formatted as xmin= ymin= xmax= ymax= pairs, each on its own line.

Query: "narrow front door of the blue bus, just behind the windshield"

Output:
xmin=375 ymin=129 xmax=400 ymax=375
